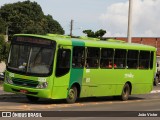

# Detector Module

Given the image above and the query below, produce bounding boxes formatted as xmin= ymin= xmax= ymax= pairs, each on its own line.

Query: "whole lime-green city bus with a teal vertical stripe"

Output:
xmin=4 ymin=34 xmax=156 ymax=103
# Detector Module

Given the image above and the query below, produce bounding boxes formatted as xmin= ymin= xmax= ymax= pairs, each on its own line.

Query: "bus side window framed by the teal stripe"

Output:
xmin=72 ymin=46 xmax=85 ymax=68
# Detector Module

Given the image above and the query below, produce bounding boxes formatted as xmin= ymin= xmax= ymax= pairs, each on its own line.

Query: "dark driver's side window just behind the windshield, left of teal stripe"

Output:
xmin=56 ymin=48 xmax=71 ymax=77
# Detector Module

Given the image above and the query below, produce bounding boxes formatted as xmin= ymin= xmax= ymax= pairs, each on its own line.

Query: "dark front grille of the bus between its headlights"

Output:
xmin=12 ymin=78 xmax=39 ymax=88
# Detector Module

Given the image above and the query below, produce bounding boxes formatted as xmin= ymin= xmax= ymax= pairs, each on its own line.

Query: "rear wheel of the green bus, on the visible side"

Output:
xmin=120 ymin=83 xmax=130 ymax=101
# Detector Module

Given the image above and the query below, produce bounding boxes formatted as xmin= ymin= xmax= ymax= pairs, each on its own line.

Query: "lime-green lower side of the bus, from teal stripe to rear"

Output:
xmin=81 ymin=69 xmax=153 ymax=97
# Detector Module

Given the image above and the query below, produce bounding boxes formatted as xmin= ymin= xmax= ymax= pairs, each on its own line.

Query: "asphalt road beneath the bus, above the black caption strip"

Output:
xmin=0 ymin=86 xmax=160 ymax=111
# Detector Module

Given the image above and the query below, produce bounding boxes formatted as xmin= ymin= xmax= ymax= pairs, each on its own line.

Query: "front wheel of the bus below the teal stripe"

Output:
xmin=66 ymin=86 xmax=77 ymax=103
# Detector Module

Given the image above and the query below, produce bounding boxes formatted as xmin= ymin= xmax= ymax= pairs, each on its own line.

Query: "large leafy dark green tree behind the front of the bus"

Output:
xmin=0 ymin=0 xmax=64 ymax=39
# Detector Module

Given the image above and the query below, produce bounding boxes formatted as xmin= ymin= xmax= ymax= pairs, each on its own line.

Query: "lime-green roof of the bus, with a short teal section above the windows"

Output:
xmin=15 ymin=34 xmax=156 ymax=51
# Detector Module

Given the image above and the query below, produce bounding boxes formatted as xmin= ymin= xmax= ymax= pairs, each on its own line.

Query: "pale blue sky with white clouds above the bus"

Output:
xmin=0 ymin=0 xmax=160 ymax=37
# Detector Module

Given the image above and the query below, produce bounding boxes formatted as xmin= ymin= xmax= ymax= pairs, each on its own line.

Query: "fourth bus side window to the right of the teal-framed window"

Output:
xmin=127 ymin=50 xmax=139 ymax=69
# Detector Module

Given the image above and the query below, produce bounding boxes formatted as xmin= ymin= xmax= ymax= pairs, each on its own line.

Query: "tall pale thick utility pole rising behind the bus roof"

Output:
xmin=127 ymin=0 xmax=133 ymax=43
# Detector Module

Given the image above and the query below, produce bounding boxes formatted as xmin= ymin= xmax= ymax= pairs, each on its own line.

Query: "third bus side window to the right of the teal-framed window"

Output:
xmin=114 ymin=49 xmax=126 ymax=69
